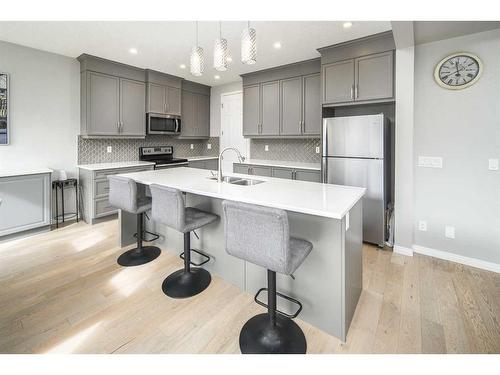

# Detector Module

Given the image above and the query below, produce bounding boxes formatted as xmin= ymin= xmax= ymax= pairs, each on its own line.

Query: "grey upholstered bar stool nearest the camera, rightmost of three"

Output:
xmin=222 ymin=201 xmax=313 ymax=354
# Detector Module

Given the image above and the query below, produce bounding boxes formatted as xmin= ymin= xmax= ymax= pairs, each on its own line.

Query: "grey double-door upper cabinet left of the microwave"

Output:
xmin=78 ymin=55 xmax=146 ymax=138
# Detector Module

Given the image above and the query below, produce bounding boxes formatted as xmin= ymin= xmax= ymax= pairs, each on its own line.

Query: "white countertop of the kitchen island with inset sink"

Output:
xmin=121 ymin=167 xmax=366 ymax=219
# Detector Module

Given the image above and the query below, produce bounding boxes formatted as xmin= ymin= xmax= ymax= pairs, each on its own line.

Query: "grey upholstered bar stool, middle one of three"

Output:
xmin=150 ymin=184 xmax=219 ymax=298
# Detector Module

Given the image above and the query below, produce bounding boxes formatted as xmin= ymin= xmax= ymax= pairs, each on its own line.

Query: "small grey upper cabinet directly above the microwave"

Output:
xmin=146 ymin=69 xmax=182 ymax=116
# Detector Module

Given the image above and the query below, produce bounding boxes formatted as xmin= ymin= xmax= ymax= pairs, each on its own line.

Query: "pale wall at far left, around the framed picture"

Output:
xmin=0 ymin=41 xmax=80 ymax=214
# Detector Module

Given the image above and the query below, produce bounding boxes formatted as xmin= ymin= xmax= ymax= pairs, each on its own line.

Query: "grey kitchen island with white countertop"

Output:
xmin=115 ymin=168 xmax=365 ymax=341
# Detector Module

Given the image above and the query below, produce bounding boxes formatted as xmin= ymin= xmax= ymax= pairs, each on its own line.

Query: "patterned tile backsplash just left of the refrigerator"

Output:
xmin=250 ymin=138 xmax=321 ymax=163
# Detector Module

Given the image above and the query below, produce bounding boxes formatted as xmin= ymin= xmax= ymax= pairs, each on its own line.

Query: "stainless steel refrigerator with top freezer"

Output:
xmin=321 ymin=114 xmax=392 ymax=246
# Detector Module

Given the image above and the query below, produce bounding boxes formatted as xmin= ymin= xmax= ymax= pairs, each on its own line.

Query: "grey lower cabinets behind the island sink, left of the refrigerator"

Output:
xmin=233 ymin=163 xmax=321 ymax=182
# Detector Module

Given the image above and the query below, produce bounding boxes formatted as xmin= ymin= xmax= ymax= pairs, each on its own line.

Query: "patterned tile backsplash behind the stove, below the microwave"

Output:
xmin=78 ymin=135 xmax=219 ymax=164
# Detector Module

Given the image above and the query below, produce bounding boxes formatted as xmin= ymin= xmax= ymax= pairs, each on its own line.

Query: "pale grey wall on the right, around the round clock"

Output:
xmin=412 ymin=30 xmax=500 ymax=264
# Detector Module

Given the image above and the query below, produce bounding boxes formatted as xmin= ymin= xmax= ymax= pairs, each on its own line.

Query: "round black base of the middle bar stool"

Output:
xmin=161 ymin=268 xmax=212 ymax=298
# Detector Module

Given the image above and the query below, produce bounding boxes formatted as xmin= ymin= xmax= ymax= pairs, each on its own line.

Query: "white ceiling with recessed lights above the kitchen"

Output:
xmin=0 ymin=21 xmax=391 ymax=86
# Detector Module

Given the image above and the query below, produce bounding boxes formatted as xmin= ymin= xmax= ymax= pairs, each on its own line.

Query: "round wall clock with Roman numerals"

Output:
xmin=434 ymin=52 xmax=483 ymax=90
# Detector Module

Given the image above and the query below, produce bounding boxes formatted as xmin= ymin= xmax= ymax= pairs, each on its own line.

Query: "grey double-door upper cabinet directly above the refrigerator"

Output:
xmin=318 ymin=32 xmax=395 ymax=106
